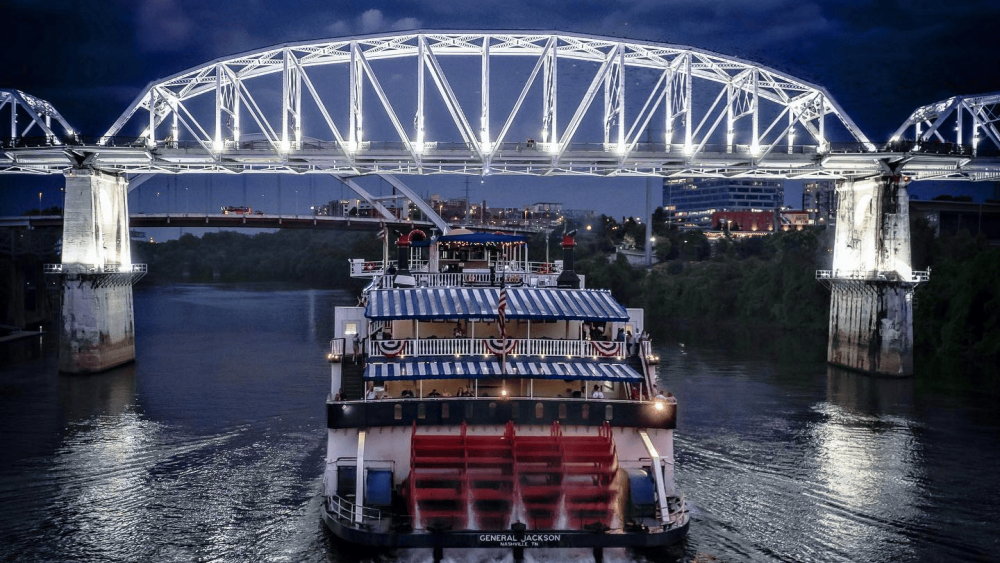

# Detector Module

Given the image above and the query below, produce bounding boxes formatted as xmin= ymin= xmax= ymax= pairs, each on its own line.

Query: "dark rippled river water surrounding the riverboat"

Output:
xmin=0 ymin=285 xmax=1000 ymax=563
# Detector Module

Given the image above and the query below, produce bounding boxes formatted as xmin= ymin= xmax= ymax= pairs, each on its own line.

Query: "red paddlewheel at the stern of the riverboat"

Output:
xmin=404 ymin=422 xmax=620 ymax=530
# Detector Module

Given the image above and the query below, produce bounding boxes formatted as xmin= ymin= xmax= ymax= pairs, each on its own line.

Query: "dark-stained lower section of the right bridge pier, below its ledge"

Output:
xmin=827 ymin=280 xmax=913 ymax=376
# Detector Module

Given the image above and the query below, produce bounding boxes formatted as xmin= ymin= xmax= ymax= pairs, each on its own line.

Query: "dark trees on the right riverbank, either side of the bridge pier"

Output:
xmin=564 ymin=217 xmax=1000 ymax=371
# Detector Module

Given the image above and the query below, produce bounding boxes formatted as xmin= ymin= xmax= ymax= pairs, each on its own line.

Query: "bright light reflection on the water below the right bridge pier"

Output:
xmin=810 ymin=368 xmax=926 ymax=561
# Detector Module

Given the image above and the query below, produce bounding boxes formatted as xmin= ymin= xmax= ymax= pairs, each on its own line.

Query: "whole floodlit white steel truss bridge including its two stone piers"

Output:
xmin=0 ymin=31 xmax=1000 ymax=374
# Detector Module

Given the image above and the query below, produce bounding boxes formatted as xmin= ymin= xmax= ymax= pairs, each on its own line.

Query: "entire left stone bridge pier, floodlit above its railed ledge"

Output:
xmin=54 ymin=169 xmax=139 ymax=373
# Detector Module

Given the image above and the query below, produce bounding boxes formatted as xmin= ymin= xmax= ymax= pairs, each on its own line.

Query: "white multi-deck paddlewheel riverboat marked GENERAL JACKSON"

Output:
xmin=321 ymin=229 xmax=689 ymax=561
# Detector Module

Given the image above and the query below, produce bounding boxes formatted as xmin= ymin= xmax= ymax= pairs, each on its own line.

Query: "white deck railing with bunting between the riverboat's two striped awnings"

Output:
xmin=365 ymin=336 xmax=625 ymax=358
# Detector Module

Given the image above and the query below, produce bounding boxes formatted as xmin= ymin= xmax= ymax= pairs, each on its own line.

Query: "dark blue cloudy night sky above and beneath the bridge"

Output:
xmin=0 ymin=0 xmax=1000 ymax=220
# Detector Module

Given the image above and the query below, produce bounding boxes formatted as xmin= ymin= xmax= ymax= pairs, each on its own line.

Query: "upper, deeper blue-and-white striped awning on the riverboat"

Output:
xmin=365 ymin=287 xmax=628 ymax=322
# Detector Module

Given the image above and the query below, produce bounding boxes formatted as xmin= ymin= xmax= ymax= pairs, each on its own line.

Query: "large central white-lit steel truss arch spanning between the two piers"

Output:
xmin=99 ymin=31 xmax=874 ymax=175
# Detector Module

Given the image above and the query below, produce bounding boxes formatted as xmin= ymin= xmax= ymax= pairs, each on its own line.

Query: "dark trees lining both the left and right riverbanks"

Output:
xmin=134 ymin=214 xmax=1000 ymax=363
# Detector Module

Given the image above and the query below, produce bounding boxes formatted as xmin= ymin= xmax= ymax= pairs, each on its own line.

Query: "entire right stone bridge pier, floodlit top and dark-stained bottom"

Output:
xmin=819 ymin=175 xmax=923 ymax=376
